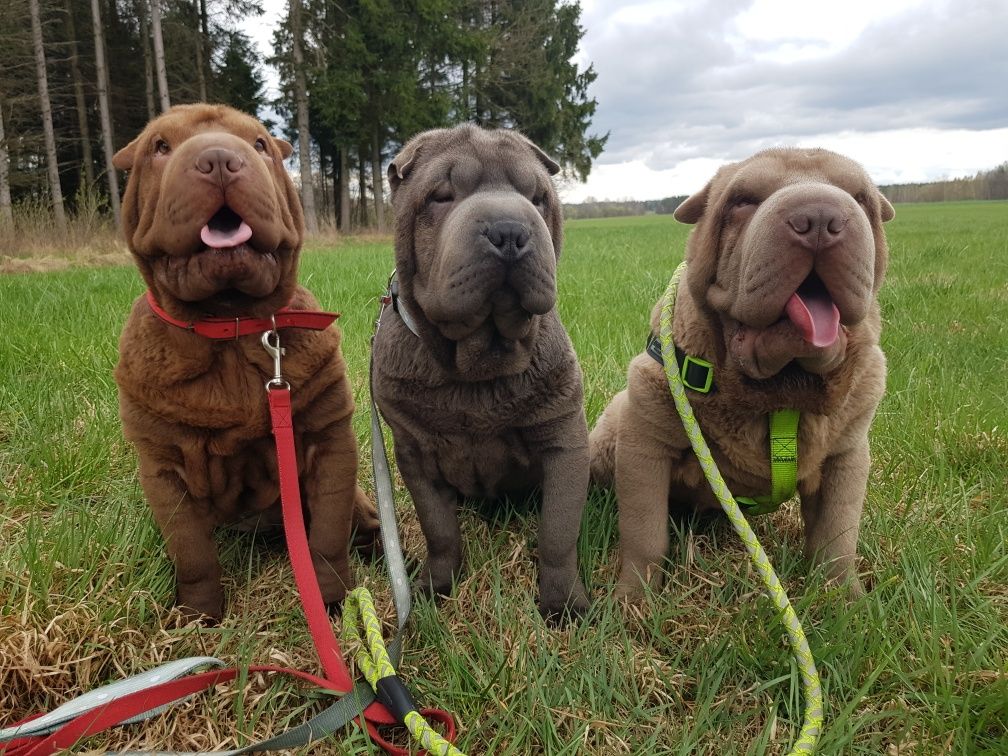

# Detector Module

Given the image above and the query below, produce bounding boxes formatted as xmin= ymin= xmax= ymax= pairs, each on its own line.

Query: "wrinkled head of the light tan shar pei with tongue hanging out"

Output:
xmin=675 ymin=149 xmax=893 ymax=379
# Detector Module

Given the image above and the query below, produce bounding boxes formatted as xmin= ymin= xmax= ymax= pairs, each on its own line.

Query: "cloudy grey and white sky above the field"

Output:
xmin=246 ymin=0 xmax=1008 ymax=203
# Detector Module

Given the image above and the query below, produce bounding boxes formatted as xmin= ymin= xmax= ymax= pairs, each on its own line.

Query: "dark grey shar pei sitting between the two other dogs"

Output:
xmin=374 ymin=125 xmax=589 ymax=619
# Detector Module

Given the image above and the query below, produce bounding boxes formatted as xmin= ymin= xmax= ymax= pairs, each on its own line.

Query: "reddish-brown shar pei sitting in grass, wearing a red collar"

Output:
xmin=114 ymin=105 xmax=377 ymax=618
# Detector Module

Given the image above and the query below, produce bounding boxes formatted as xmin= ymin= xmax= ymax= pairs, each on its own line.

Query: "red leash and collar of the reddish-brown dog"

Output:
xmin=0 ymin=290 xmax=456 ymax=756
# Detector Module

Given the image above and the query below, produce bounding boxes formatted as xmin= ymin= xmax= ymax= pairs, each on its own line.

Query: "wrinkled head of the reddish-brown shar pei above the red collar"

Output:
xmin=114 ymin=105 xmax=303 ymax=320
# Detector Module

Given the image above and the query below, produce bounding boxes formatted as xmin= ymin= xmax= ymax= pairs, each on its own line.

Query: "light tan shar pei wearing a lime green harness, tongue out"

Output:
xmin=591 ymin=149 xmax=893 ymax=596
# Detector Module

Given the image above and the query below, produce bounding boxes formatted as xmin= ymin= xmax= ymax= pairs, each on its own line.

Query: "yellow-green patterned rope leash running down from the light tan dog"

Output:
xmin=660 ymin=262 xmax=824 ymax=756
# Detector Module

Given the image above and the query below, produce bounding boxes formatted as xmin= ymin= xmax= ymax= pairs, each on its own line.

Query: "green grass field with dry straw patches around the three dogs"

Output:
xmin=0 ymin=203 xmax=1008 ymax=754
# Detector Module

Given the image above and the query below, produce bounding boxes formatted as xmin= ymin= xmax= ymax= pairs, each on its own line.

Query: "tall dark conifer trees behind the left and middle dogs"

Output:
xmin=0 ymin=0 xmax=607 ymax=230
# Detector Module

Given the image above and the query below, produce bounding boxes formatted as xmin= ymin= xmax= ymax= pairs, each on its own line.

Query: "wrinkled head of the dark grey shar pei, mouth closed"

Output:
xmin=389 ymin=125 xmax=561 ymax=347
